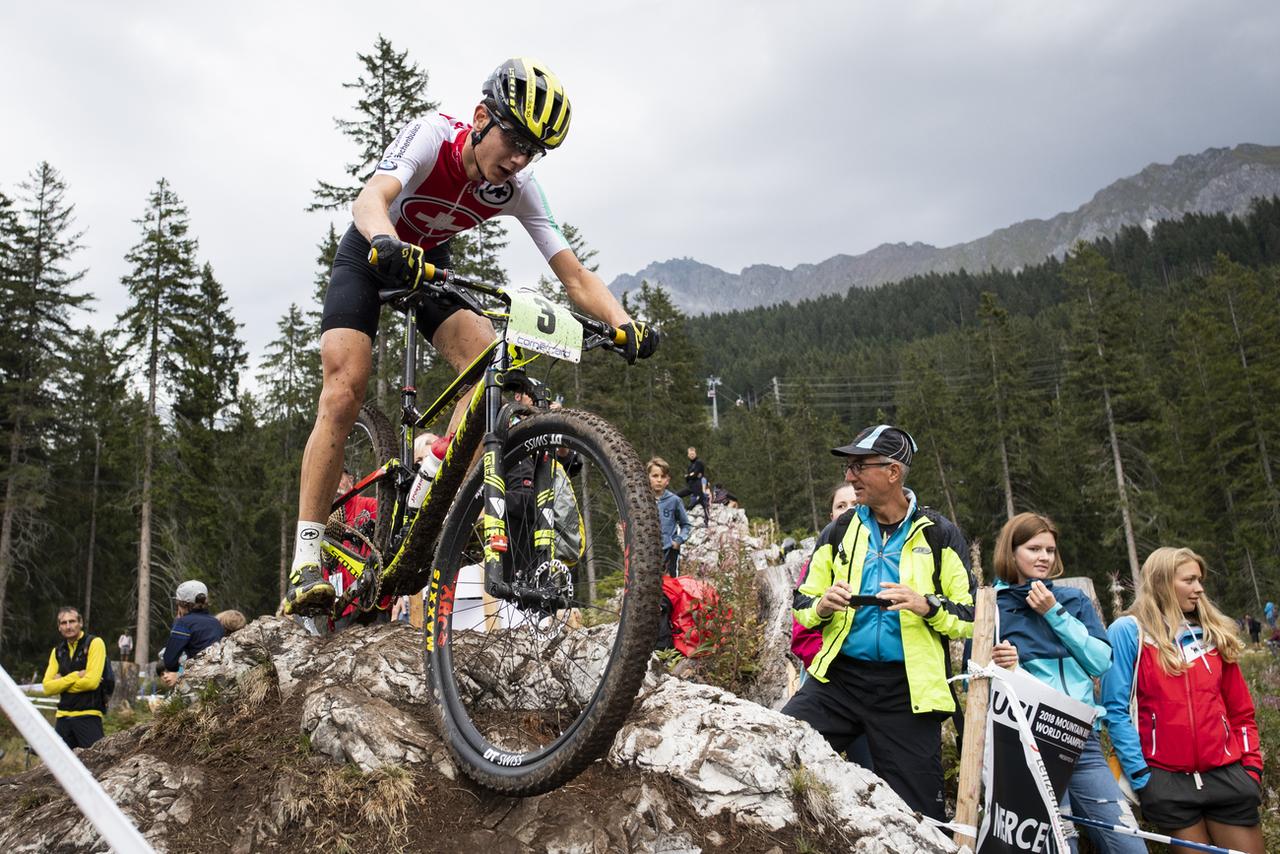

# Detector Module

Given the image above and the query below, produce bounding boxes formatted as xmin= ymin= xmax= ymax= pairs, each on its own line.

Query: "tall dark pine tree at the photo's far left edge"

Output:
xmin=0 ymin=163 xmax=91 ymax=644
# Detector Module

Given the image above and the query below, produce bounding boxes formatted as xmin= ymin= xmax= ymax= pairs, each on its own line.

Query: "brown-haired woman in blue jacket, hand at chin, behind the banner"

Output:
xmin=991 ymin=513 xmax=1147 ymax=854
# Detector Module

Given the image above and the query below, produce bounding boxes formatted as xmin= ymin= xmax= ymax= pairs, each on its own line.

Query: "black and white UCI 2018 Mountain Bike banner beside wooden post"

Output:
xmin=978 ymin=668 xmax=1094 ymax=854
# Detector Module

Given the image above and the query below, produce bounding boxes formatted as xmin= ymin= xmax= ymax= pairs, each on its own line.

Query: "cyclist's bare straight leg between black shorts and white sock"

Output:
xmin=298 ymin=329 xmax=372 ymax=522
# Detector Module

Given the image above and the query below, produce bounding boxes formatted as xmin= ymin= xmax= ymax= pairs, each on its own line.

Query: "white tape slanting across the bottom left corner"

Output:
xmin=0 ymin=667 xmax=152 ymax=854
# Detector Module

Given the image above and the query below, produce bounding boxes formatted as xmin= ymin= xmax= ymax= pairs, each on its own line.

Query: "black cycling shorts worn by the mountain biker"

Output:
xmin=320 ymin=224 xmax=462 ymax=341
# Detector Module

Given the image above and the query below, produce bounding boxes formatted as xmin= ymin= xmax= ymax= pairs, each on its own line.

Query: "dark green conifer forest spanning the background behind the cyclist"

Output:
xmin=0 ymin=38 xmax=1280 ymax=680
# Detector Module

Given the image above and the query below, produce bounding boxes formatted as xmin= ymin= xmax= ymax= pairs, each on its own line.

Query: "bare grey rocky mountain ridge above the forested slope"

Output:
xmin=609 ymin=143 xmax=1280 ymax=315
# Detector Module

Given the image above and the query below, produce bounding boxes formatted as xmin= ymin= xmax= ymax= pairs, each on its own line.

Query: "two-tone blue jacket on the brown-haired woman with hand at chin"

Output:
xmin=996 ymin=580 xmax=1111 ymax=730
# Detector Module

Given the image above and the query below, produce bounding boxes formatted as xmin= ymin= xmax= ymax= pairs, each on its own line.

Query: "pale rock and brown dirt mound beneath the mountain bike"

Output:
xmin=0 ymin=508 xmax=955 ymax=854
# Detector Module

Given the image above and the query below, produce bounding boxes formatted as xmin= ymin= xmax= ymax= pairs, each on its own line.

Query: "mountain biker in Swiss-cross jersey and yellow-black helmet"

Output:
xmin=285 ymin=58 xmax=658 ymax=613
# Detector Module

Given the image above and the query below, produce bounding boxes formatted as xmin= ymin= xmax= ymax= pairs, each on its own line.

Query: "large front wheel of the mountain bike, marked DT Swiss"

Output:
xmin=426 ymin=411 xmax=662 ymax=795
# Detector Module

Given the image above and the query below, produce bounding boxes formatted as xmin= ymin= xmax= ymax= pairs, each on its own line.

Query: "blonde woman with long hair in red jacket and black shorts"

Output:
xmin=1102 ymin=547 xmax=1263 ymax=854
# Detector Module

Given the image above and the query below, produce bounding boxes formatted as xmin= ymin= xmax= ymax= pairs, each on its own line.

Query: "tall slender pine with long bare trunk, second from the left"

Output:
xmin=119 ymin=178 xmax=200 ymax=668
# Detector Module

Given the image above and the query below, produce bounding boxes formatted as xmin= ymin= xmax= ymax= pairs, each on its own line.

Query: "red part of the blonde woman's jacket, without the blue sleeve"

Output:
xmin=1137 ymin=627 xmax=1262 ymax=781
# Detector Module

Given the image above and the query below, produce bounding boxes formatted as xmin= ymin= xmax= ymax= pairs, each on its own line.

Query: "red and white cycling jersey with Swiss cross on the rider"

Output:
xmin=374 ymin=113 xmax=568 ymax=260
